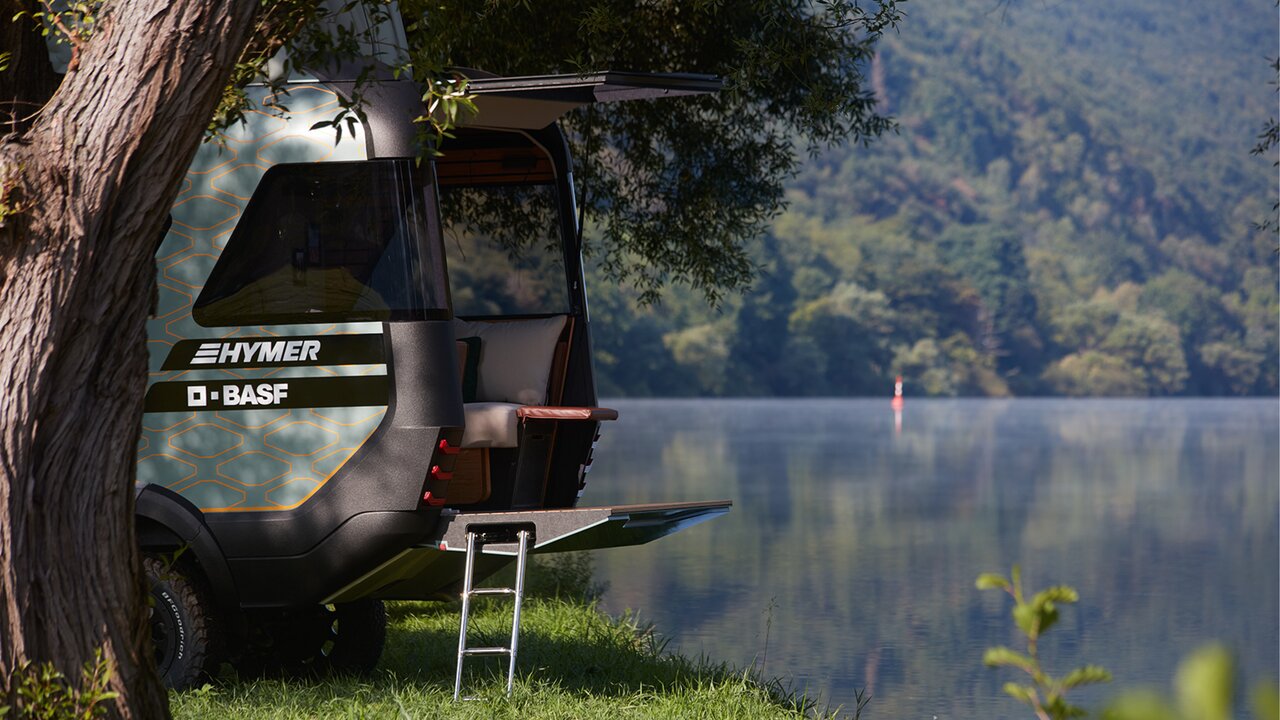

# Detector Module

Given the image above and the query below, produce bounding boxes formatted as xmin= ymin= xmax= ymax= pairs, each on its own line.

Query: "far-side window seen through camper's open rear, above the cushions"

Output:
xmin=440 ymin=184 xmax=568 ymax=315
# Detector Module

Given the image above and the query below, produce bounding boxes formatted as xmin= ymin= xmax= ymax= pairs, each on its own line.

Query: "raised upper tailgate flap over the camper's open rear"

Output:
xmin=465 ymin=70 xmax=723 ymax=129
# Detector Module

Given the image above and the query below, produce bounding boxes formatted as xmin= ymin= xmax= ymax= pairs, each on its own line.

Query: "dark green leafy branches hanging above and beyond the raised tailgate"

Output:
xmin=401 ymin=0 xmax=899 ymax=300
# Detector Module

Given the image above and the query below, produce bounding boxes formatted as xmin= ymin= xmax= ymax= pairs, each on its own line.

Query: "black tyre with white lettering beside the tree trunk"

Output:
xmin=142 ymin=556 xmax=215 ymax=691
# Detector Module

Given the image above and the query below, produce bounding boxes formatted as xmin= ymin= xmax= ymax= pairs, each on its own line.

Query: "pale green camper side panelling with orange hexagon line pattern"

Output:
xmin=137 ymin=86 xmax=387 ymax=512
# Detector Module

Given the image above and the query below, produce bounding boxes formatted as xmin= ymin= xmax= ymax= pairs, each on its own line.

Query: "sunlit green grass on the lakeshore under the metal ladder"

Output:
xmin=170 ymin=556 xmax=858 ymax=720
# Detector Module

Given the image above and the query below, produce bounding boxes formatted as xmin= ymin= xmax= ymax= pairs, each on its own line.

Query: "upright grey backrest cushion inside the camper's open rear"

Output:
xmin=453 ymin=315 xmax=564 ymax=405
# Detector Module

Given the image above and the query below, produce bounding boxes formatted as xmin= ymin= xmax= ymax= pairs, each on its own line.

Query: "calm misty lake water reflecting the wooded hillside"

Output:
xmin=584 ymin=398 xmax=1280 ymax=720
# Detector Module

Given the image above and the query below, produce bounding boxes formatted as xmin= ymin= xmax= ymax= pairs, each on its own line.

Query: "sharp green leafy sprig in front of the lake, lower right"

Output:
xmin=977 ymin=565 xmax=1111 ymax=720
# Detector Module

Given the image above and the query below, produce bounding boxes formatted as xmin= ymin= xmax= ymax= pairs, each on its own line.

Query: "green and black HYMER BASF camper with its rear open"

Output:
xmin=136 ymin=11 xmax=730 ymax=688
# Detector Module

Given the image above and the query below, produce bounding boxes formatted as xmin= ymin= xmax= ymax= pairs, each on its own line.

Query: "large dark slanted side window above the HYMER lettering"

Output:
xmin=192 ymin=160 xmax=448 ymax=327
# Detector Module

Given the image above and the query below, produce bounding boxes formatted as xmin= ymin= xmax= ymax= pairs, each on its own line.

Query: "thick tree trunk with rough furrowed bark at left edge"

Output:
xmin=0 ymin=0 xmax=260 ymax=719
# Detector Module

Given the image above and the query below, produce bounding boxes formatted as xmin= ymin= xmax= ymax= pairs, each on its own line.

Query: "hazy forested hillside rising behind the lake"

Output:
xmin=591 ymin=0 xmax=1280 ymax=396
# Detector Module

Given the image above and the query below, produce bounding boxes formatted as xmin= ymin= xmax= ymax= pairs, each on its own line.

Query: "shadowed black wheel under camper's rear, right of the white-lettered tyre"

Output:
xmin=237 ymin=600 xmax=387 ymax=676
